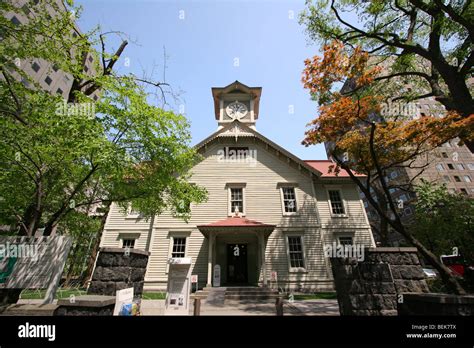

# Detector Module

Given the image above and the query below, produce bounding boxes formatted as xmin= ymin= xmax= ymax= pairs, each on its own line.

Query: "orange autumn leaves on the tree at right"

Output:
xmin=302 ymin=41 xmax=473 ymax=173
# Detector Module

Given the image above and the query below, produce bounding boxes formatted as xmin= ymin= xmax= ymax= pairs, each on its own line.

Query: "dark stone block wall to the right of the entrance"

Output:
xmin=331 ymin=248 xmax=429 ymax=315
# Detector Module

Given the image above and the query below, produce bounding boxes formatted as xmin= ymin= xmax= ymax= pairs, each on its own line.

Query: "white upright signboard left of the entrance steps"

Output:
xmin=165 ymin=257 xmax=192 ymax=315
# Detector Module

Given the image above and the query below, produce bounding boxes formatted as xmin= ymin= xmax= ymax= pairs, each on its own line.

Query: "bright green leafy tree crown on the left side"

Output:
xmin=0 ymin=0 xmax=206 ymax=235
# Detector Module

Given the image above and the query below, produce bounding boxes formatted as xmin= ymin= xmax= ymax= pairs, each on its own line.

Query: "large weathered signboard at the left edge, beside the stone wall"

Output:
xmin=0 ymin=236 xmax=72 ymax=304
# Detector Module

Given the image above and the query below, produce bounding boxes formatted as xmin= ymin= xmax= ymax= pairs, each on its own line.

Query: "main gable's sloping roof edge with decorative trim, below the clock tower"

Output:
xmin=194 ymin=120 xmax=322 ymax=177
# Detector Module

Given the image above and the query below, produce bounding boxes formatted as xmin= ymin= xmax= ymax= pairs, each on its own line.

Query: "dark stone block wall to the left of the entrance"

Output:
xmin=87 ymin=248 xmax=150 ymax=297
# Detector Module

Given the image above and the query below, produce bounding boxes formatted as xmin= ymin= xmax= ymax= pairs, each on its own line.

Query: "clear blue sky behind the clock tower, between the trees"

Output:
xmin=76 ymin=0 xmax=326 ymax=159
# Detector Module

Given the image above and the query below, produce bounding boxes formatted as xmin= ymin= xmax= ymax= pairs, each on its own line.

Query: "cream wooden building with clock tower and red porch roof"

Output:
xmin=101 ymin=81 xmax=374 ymax=291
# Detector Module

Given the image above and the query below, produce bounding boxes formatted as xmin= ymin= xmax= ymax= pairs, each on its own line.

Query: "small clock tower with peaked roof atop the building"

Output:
xmin=212 ymin=81 xmax=262 ymax=129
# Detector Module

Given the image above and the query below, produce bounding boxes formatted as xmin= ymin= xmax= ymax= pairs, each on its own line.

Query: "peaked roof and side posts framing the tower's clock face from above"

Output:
xmin=211 ymin=80 xmax=262 ymax=122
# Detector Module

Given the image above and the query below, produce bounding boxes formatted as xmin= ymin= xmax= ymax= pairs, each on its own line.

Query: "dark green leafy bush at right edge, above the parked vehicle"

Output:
xmin=411 ymin=182 xmax=474 ymax=265
